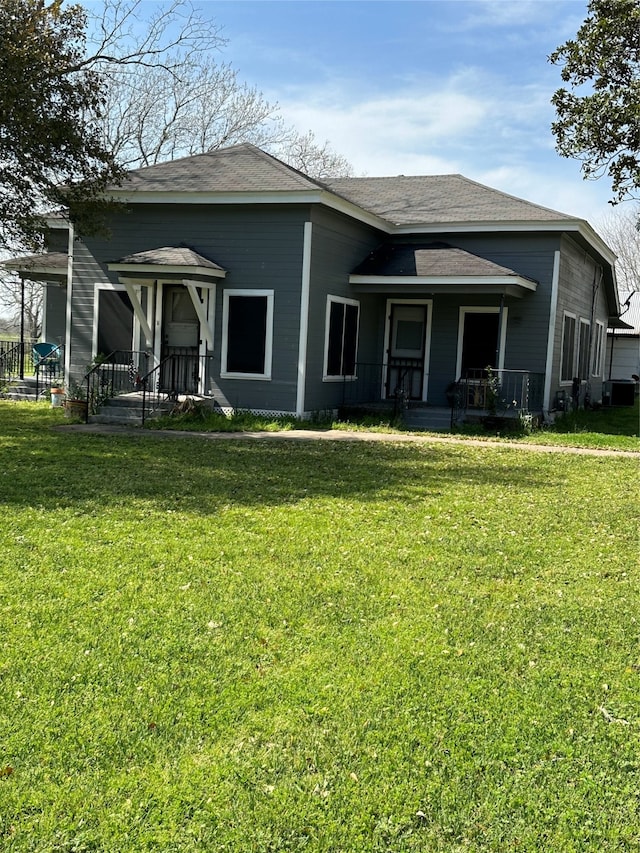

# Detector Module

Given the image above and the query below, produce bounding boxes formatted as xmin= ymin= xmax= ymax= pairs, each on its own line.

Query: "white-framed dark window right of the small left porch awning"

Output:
xmin=220 ymin=290 xmax=273 ymax=379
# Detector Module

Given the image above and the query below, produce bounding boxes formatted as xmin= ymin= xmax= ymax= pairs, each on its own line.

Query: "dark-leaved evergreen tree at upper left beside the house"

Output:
xmin=0 ymin=0 xmax=120 ymax=248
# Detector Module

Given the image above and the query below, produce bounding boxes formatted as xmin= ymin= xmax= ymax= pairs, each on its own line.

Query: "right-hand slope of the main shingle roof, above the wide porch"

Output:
xmin=326 ymin=175 xmax=575 ymax=225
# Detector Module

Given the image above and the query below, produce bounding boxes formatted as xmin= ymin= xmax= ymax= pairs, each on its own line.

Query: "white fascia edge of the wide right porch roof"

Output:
xmin=349 ymin=275 xmax=538 ymax=298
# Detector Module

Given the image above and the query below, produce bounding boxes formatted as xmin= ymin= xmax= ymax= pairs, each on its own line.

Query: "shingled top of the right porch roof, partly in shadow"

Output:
xmin=353 ymin=243 xmax=522 ymax=278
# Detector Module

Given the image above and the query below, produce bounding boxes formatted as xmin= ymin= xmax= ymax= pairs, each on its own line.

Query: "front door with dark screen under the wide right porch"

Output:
xmin=386 ymin=303 xmax=427 ymax=400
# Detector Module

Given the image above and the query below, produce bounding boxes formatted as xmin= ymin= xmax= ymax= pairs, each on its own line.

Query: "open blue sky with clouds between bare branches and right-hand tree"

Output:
xmin=181 ymin=0 xmax=611 ymax=227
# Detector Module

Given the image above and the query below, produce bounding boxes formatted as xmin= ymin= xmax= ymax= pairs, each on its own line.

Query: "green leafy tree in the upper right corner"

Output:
xmin=550 ymin=0 xmax=640 ymax=204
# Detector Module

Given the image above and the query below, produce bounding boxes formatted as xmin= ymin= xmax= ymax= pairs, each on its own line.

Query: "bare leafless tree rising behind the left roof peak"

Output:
xmin=88 ymin=0 xmax=352 ymax=178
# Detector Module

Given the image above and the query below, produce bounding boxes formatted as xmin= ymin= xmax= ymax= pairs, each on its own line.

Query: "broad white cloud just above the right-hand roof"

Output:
xmin=272 ymin=68 xmax=608 ymax=222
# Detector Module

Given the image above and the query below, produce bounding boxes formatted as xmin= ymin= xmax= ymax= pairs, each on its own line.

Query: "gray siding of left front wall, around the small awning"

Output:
xmin=72 ymin=205 xmax=308 ymax=411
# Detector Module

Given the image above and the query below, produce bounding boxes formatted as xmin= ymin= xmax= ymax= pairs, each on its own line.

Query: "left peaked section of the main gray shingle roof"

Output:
xmin=118 ymin=144 xmax=319 ymax=193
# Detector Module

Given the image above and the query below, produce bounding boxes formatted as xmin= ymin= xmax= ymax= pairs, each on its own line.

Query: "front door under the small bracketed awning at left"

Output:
xmin=160 ymin=285 xmax=200 ymax=394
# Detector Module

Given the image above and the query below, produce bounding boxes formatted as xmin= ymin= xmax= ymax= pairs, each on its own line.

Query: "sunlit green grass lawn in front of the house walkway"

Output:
xmin=0 ymin=401 xmax=640 ymax=853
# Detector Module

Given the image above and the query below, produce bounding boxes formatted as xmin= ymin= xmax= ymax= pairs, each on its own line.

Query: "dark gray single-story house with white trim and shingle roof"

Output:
xmin=1 ymin=144 xmax=620 ymax=417
